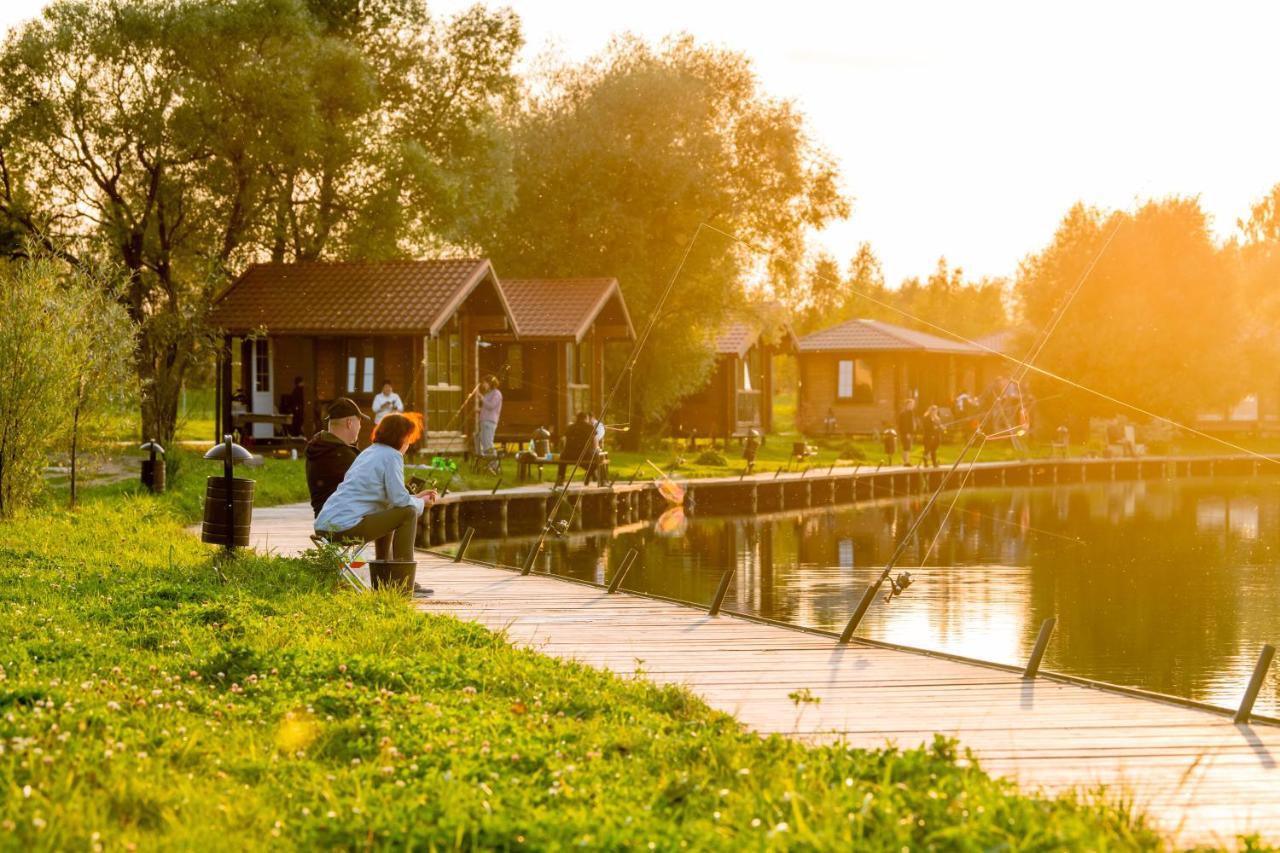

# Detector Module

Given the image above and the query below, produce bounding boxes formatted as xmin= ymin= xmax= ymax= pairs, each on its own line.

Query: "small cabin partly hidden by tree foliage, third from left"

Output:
xmin=671 ymin=319 xmax=795 ymax=439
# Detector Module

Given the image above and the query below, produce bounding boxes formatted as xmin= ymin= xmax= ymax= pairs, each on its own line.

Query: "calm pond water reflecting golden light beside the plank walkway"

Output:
xmin=468 ymin=478 xmax=1280 ymax=716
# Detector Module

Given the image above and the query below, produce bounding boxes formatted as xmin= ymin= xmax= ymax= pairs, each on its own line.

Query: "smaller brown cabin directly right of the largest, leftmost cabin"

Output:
xmin=480 ymin=278 xmax=635 ymax=442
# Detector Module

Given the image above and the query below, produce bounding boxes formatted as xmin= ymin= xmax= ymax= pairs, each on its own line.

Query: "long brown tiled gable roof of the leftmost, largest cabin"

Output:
xmin=210 ymin=257 xmax=520 ymax=334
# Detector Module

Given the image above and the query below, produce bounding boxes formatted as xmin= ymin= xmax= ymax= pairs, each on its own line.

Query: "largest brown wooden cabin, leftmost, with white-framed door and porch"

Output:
xmin=210 ymin=259 xmax=520 ymax=447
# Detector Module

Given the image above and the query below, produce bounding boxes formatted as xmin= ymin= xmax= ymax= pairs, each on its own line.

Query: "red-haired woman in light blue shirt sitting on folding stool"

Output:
xmin=315 ymin=414 xmax=435 ymax=561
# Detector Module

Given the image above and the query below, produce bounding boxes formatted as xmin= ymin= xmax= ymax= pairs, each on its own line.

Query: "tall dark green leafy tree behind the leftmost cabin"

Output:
xmin=0 ymin=0 xmax=520 ymax=442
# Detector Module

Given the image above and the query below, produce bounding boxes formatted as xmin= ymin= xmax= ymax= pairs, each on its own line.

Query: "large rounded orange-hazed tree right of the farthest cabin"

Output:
xmin=1016 ymin=197 xmax=1243 ymax=419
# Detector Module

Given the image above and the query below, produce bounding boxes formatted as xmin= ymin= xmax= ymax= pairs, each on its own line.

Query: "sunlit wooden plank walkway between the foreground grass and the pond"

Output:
xmin=244 ymin=505 xmax=1280 ymax=847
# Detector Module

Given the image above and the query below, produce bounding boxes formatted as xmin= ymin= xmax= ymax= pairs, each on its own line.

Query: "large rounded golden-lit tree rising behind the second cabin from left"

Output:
xmin=484 ymin=37 xmax=847 ymax=441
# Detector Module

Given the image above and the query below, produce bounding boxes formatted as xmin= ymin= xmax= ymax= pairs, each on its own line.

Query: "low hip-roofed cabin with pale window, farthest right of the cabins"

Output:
xmin=796 ymin=320 xmax=998 ymax=435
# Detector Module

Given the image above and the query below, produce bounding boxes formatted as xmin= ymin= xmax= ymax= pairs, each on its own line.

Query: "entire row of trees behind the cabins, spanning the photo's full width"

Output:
xmin=0 ymin=0 xmax=1280 ymax=442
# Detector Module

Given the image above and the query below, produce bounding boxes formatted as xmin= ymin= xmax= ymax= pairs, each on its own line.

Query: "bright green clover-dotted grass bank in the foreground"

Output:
xmin=0 ymin=494 xmax=1187 ymax=850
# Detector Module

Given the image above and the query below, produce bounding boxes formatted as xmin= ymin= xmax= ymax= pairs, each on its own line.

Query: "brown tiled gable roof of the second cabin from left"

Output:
xmin=500 ymin=278 xmax=635 ymax=341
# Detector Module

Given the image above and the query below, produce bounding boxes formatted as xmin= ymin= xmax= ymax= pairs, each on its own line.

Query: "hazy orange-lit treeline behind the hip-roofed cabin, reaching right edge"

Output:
xmin=782 ymin=190 xmax=1280 ymax=427
